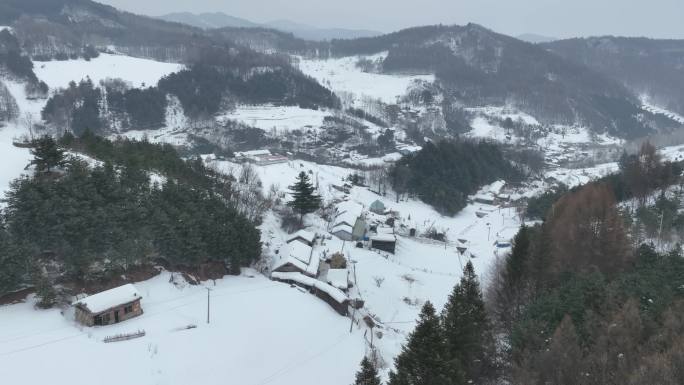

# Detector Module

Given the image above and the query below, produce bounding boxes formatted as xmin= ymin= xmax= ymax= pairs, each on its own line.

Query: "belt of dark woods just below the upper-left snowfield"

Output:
xmin=42 ymin=64 xmax=339 ymax=135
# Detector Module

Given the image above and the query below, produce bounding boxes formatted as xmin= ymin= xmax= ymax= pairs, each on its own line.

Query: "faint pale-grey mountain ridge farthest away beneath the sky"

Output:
xmin=158 ymin=12 xmax=382 ymax=41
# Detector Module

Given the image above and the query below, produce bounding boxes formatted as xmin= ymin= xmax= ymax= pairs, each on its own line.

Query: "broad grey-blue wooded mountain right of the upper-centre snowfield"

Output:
xmin=312 ymin=24 xmax=680 ymax=137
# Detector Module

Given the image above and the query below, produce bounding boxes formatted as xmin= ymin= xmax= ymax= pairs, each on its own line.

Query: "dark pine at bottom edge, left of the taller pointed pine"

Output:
xmin=389 ymin=302 xmax=463 ymax=385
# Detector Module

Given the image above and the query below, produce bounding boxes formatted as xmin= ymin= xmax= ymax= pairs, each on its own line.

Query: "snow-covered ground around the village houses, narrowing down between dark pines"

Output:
xmin=211 ymin=161 xmax=520 ymax=368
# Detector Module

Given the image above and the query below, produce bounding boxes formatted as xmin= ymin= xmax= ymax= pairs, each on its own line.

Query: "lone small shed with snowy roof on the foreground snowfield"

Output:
xmin=72 ymin=283 xmax=143 ymax=326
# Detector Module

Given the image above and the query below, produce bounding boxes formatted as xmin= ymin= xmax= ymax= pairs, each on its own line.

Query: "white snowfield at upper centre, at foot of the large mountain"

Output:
xmin=299 ymin=54 xmax=435 ymax=104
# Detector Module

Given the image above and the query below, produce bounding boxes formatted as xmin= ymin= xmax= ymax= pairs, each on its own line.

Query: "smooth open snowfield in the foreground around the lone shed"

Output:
xmin=0 ymin=272 xmax=365 ymax=385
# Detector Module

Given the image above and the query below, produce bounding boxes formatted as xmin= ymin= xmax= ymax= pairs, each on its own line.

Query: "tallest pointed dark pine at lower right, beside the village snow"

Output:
xmin=442 ymin=261 xmax=493 ymax=383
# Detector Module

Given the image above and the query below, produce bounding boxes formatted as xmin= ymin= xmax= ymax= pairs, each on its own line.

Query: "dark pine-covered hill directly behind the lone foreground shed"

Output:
xmin=0 ymin=133 xmax=261 ymax=293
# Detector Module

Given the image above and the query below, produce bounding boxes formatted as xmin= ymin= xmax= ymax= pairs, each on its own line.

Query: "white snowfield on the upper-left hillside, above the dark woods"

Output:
xmin=34 ymin=53 xmax=184 ymax=88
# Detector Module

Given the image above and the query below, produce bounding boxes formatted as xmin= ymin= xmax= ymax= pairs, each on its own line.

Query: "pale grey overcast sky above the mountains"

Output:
xmin=96 ymin=0 xmax=684 ymax=38
